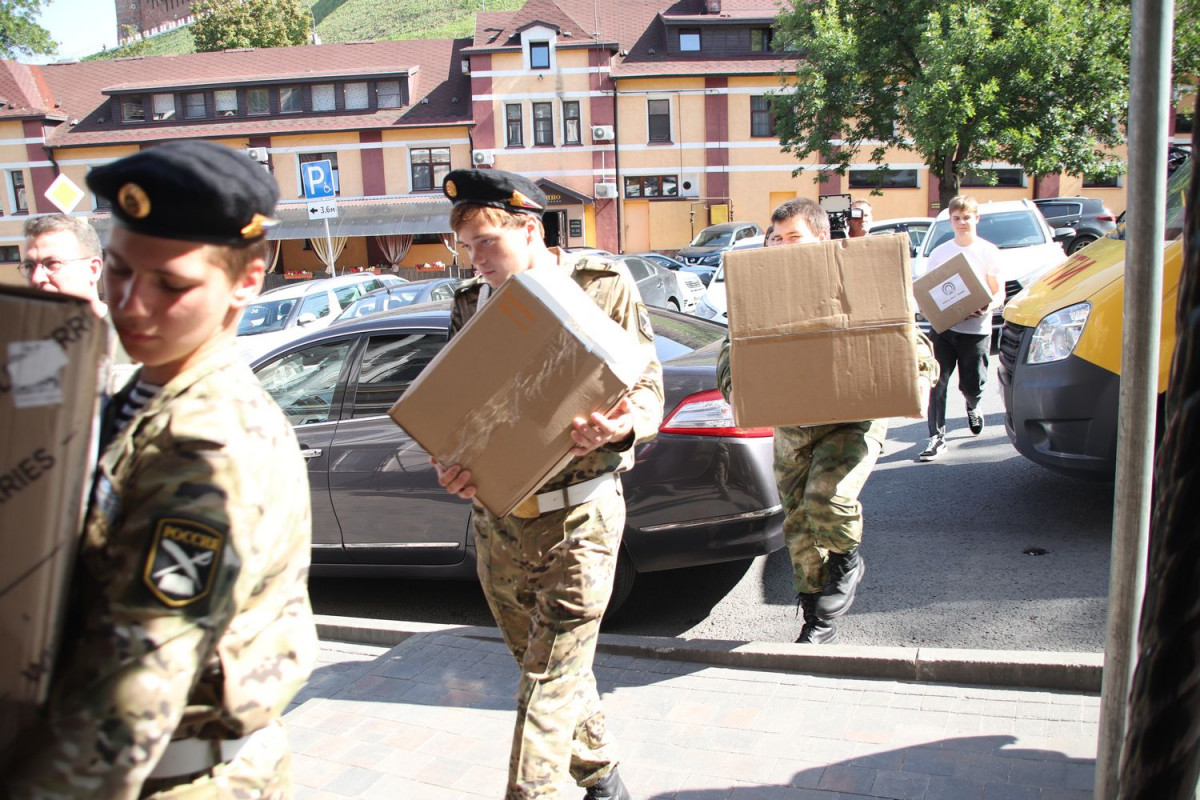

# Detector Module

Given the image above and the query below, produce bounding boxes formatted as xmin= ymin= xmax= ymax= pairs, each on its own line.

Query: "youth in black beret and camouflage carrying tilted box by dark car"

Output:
xmin=434 ymin=169 xmax=662 ymax=800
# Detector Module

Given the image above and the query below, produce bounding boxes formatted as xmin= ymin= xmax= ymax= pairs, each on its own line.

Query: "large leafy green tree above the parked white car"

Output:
xmin=773 ymin=0 xmax=1129 ymax=207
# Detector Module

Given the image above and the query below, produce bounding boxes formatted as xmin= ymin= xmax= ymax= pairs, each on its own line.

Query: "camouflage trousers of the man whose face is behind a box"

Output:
xmin=775 ymin=420 xmax=887 ymax=594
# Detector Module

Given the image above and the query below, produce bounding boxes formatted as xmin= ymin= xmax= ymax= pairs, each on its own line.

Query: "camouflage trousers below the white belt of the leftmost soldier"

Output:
xmin=140 ymin=720 xmax=292 ymax=800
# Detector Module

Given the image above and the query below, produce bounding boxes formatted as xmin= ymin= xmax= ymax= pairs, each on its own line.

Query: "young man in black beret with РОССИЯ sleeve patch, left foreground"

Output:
xmin=4 ymin=142 xmax=317 ymax=800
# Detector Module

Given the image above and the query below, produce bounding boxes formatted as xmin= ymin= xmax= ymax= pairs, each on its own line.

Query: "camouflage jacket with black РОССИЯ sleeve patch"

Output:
xmin=8 ymin=347 xmax=317 ymax=798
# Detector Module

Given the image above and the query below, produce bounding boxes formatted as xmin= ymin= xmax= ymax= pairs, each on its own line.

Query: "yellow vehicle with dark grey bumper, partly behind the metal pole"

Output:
xmin=997 ymin=160 xmax=1192 ymax=481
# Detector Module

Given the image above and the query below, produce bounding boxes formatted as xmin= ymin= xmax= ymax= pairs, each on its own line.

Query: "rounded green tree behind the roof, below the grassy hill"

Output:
xmin=192 ymin=0 xmax=312 ymax=52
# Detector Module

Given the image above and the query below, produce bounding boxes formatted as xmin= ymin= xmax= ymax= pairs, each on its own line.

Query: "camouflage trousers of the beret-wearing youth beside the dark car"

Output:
xmin=474 ymin=485 xmax=625 ymax=800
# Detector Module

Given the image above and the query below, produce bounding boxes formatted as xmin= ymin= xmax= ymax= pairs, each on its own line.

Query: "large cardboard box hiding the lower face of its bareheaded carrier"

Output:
xmin=725 ymin=236 xmax=920 ymax=427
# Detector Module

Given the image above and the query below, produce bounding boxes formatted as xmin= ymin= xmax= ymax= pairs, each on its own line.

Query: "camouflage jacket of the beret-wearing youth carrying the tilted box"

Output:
xmin=450 ymin=248 xmax=664 ymax=491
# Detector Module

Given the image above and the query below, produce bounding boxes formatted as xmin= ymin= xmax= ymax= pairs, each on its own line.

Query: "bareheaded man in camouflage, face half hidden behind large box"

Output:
xmin=716 ymin=198 xmax=887 ymax=644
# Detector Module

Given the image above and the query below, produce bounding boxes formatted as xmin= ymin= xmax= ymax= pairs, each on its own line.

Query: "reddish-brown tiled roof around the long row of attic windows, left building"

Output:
xmin=14 ymin=40 xmax=470 ymax=146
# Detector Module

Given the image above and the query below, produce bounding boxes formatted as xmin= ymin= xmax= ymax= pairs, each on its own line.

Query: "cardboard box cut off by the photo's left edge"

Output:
xmin=0 ymin=287 xmax=108 ymax=750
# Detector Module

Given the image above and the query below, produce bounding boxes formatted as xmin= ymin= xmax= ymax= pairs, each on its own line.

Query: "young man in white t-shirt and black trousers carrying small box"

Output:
xmin=920 ymin=194 xmax=1004 ymax=461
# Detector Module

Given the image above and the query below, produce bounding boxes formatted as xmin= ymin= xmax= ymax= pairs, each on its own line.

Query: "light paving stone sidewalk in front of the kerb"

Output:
xmin=286 ymin=632 xmax=1099 ymax=800
